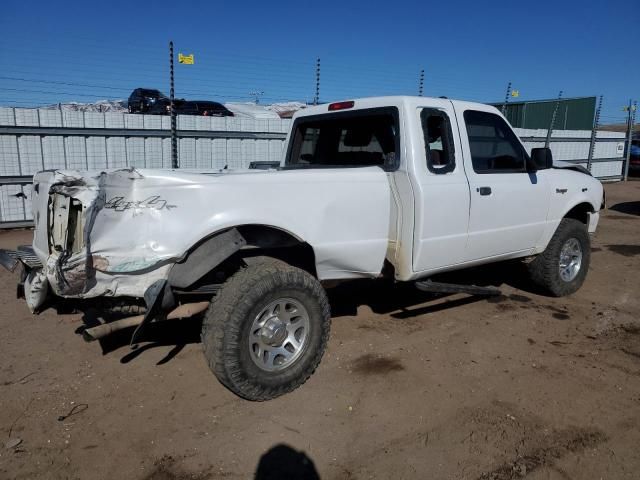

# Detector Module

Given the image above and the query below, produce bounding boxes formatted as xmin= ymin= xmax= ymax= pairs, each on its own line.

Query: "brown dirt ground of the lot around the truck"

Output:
xmin=0 ymin=181 xmax=640 ymax=480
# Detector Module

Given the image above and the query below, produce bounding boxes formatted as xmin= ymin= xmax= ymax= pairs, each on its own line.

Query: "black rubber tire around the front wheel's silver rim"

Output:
xmin=528 ymin=218 xmax=591 ymax=297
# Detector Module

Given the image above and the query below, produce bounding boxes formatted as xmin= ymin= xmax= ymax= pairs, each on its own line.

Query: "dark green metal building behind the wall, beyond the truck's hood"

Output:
xmin=491 ymin=97 xmax=596 ymax=130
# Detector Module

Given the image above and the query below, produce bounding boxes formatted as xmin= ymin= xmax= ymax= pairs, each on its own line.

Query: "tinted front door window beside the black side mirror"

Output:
xmin=464 ymin=110 xmax=527 ymax=173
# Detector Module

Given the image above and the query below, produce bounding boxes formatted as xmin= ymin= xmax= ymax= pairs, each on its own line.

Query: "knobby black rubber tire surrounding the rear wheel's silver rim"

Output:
xmin=202 ymin=257 xmax=331 ymax=401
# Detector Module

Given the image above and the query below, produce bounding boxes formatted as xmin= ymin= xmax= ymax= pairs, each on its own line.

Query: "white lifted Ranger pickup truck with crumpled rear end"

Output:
xmin=0 ymin=97 xmax=604 ymax=400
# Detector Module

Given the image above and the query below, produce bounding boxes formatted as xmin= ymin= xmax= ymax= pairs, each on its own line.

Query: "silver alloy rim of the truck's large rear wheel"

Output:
xmin=249 ymin=298 xmax=309 ymax=372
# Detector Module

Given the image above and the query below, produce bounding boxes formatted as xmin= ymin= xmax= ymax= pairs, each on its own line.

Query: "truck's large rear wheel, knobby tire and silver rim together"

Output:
xmin=202 ymin=258 xmax=331 ymax=401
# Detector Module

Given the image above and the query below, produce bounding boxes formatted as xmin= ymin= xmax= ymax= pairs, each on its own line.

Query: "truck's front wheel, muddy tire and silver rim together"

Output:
xmin=529 ymin=218 xmax=591 ymax=297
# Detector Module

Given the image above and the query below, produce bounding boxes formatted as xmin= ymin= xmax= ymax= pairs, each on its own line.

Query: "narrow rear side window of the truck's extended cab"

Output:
xmin=420 ymin=108 xmax=456 ymax=173
